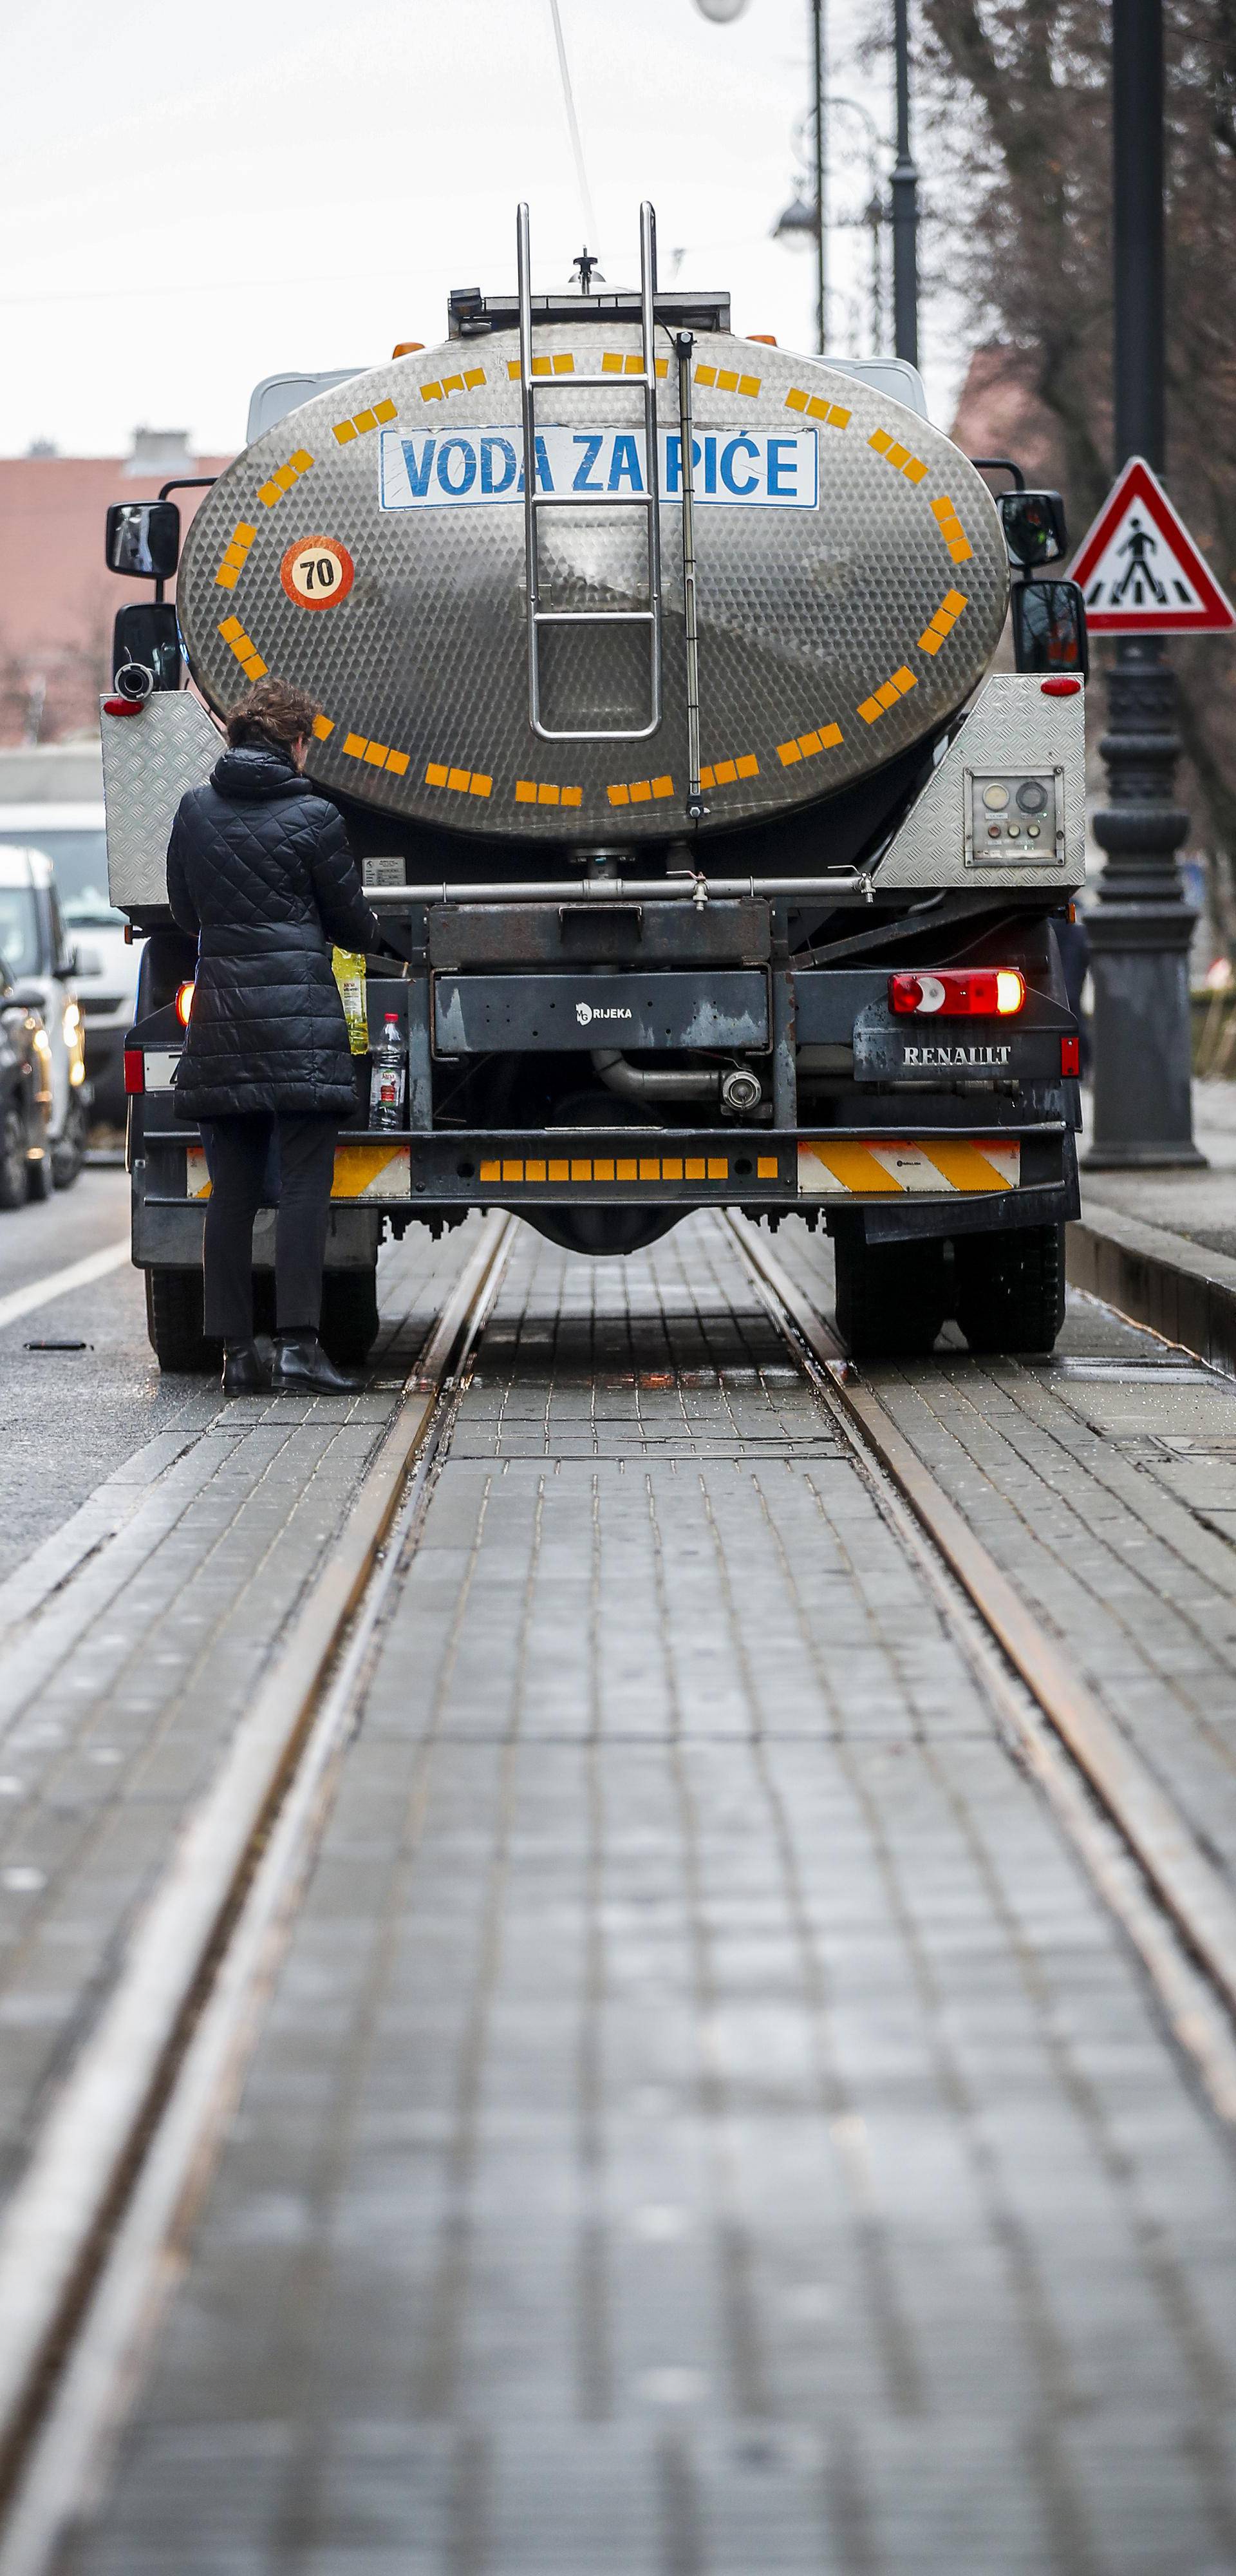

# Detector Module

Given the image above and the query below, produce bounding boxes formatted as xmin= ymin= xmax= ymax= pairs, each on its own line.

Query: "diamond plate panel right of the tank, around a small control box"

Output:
xmin=876 ymin=672 xmax=1087 ymax=894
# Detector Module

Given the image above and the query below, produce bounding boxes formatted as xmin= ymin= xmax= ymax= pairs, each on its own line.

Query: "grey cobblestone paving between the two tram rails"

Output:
xmin=59 ymin=1218 xmax=1236 ymax=2576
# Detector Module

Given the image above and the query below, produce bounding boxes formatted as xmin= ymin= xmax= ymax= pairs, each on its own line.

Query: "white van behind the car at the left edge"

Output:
xmin=0 ymin=804 xmax=142 ymax=1126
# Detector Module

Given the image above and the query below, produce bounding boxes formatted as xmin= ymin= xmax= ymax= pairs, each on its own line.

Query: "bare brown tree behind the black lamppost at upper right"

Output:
xmin=922 ymin=0 xmax=1236 ymax=866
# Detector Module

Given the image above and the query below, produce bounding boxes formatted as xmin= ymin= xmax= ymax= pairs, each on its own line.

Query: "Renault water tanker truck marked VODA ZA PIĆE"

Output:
xmin=103 ymin=209 xmax=1087 ymax=1368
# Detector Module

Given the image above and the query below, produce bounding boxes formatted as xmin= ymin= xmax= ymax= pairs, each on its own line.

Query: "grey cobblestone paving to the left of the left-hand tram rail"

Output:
xmin=0 ymin=1216 xmax=484 ymax=2197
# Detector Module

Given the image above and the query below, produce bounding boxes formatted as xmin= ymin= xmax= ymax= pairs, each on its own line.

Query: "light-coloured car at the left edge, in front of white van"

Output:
xmin=0 ymin=845 xmax=88 ymax=1198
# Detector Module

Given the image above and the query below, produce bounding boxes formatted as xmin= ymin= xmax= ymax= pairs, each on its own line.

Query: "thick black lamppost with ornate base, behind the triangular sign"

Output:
xmin=1087 ymin=0 xmax=1205 ymax=1172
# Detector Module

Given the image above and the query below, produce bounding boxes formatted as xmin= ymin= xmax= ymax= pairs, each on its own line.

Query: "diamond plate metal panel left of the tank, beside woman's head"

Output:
xmin=98 ymin=690 xmax=224 ymax=912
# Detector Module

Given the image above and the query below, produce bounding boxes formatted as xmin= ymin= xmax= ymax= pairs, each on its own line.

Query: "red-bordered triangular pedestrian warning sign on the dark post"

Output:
xmin=1071 ymin=456 xmax=1236 ymax=636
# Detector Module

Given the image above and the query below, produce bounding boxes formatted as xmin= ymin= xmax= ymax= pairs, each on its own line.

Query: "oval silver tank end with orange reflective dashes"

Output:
xmin=178 ymin=322 xmax=1007 ymax=850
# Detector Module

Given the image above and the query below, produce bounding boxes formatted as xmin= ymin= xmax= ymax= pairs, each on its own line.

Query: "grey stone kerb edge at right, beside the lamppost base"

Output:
xmin=1066 ymin=1203 xmax=1236 ymax=1378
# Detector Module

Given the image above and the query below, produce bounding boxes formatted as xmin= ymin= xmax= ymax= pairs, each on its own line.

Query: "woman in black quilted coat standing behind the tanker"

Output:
xmin=167 ymin=680 xmax=384 ymax=1396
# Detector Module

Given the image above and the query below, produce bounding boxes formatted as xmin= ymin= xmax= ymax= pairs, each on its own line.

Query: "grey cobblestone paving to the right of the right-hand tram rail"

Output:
xmin=783 ymin=1226 xmax=1236 ymax=1873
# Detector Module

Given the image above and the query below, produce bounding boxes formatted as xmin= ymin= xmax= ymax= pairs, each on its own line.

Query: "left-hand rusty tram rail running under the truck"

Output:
xmin=0 ymin=1213 xmax=512 ymax=2576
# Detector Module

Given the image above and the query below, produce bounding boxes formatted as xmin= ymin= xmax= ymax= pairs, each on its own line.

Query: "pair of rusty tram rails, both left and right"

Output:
xmin=0 ymin=1216 xmax=1236 ymax=2576
